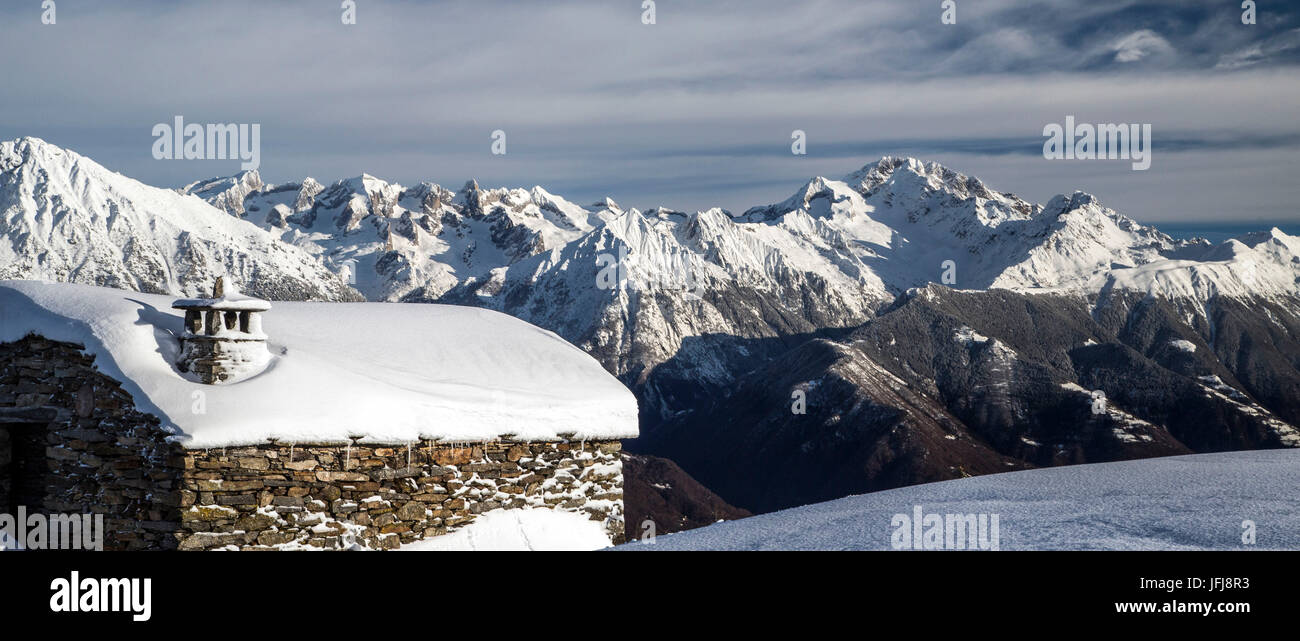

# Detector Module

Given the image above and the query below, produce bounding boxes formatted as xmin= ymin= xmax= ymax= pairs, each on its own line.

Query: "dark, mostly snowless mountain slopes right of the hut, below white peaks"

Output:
xmin=637 ymin=285 xmax=1300 ymax=511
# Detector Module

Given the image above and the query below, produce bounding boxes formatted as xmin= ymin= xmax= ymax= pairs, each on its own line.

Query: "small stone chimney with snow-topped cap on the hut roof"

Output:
xmin=172 ymin=277 xmax=270 ymax=385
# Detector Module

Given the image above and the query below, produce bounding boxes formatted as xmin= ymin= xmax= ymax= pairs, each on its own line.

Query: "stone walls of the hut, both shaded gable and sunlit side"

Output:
xmin=0 ymin=337 xmax=624 ymax=550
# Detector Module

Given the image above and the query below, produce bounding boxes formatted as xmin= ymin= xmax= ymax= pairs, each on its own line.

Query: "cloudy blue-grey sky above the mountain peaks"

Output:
xmin=0 ymin=0 xmax=1300 ymax=222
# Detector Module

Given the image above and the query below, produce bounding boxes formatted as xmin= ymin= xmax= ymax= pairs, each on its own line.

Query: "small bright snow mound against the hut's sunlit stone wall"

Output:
xmin=399 ymin=510 xmax=610 ymax=551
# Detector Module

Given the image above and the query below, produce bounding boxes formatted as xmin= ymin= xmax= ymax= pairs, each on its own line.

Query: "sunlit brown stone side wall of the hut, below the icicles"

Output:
xmin=181 ymin=441 xmax=624 ymax=550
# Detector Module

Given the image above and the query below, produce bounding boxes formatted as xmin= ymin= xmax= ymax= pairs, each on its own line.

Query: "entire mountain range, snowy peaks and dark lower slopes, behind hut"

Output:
xmin=0 ymin=138 xmax=1300 ymax=511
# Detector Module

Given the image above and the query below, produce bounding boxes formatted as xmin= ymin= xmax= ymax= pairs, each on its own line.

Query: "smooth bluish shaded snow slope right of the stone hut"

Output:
xmin=620 ymin=450 xmax=1300 ymax=550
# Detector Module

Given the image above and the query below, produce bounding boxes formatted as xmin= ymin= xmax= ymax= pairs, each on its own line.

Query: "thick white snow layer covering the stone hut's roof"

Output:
xmin=0 ymin=276 xmax=637 ymax=449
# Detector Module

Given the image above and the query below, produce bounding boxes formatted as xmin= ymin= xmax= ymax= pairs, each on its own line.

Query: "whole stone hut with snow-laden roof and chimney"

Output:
xmin=0 ymin=281 xmax=637 ymax=550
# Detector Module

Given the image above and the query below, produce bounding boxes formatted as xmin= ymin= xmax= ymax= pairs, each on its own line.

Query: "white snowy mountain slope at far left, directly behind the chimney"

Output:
xmin=0 ymin=138 xmax=359 ymax=300
